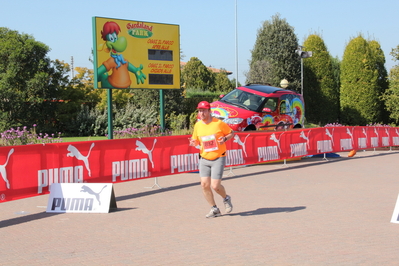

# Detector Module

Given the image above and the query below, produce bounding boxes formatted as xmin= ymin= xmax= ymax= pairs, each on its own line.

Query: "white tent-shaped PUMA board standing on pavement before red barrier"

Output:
xmin=46 ymin=183 xmax=116 ymax=213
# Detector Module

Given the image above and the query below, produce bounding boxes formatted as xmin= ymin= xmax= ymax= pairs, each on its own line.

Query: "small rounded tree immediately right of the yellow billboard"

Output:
xmin=181 ymin=57 xmax=214 ymax=90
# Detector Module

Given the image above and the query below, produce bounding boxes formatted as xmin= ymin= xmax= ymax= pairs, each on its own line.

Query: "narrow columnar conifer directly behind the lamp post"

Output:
xmin=303 ymin=34 xmax=339 ymax=124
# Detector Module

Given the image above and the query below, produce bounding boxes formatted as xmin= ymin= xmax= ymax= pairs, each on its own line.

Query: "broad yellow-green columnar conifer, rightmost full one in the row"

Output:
xmin=340 ymin=35 xmax=385 ymax=125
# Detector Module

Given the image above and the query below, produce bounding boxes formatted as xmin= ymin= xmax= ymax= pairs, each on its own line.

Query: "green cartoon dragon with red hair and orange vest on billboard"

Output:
xmin=97 ymin=21 xmax=147 ymax=89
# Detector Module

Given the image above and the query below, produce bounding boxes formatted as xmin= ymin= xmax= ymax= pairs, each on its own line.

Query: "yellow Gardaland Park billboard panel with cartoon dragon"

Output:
xmin=93 ymin=17 xmax=180 ymax=89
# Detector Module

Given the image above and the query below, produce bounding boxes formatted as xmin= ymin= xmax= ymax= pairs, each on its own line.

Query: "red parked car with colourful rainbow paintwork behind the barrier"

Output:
xmin=211 ymin=84 xmax=305 ymax=131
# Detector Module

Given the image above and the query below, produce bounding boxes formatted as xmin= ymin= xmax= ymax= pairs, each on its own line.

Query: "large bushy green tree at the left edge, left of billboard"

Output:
xmin=0 ymin=28 xmax=68 ymax=132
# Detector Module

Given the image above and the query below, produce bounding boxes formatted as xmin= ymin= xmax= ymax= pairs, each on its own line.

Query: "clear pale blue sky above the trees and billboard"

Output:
xmin=0 ymin=0 xmax=399 ymax=84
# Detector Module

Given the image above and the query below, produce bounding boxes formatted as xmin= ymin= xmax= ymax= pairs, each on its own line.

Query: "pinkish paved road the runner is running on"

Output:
xmin=0 ymin=151 xmax=399 ymax=266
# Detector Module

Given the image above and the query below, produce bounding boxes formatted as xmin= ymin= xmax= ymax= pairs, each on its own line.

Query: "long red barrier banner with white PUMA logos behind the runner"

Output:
xmin=0 ymin=127 xmax=399 ymax=202
